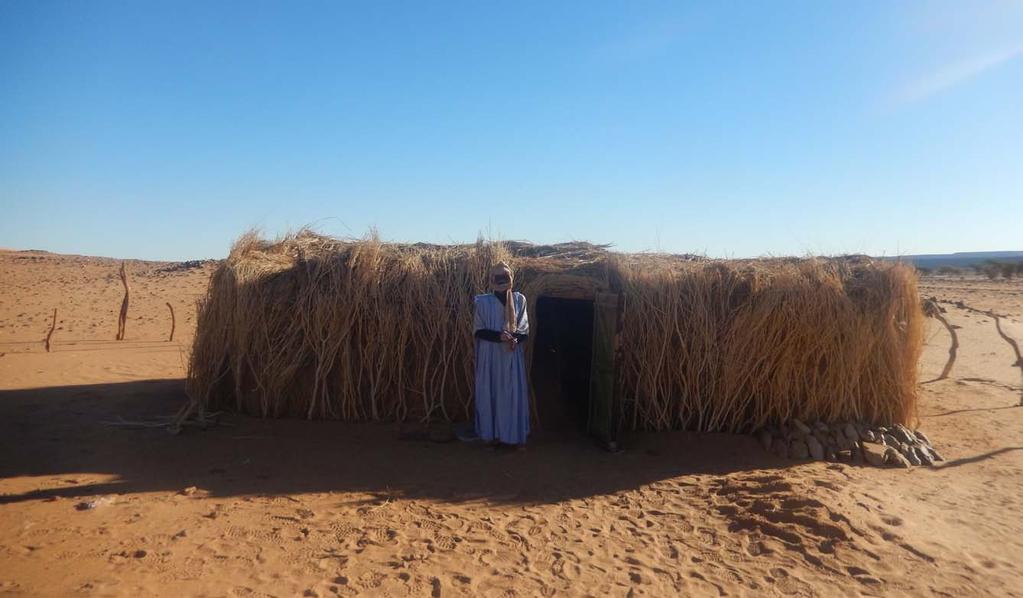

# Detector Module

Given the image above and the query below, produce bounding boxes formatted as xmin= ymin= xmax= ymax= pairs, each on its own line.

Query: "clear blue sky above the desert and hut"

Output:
xmin=0 ymin=0 xmax=1023 ymax=259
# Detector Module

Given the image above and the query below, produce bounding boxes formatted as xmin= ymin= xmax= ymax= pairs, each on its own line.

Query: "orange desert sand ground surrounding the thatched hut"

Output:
xmin=0 ymin=251 xmax=1023 ymax=596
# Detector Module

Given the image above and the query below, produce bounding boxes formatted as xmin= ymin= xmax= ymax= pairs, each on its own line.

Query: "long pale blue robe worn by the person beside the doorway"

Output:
xmin=473 ymin=292 xmax=529 ymax=445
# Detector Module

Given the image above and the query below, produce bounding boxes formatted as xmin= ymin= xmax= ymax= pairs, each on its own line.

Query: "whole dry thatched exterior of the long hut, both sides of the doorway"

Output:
xmin=188 ymin=232 xmax=923 ymax=431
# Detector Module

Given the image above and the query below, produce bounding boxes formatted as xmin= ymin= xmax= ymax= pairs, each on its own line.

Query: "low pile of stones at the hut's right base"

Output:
xmin=755 ymin=419 xmax=944 ymax=467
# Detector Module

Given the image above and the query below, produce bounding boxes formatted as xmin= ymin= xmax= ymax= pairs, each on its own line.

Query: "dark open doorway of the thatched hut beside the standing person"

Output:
xmin=532 ymin=296 xmax=593 ymax=434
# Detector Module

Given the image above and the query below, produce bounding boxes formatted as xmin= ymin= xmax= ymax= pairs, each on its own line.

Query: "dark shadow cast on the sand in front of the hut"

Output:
xmin=0 ymin=380 xmax=795 ymax=504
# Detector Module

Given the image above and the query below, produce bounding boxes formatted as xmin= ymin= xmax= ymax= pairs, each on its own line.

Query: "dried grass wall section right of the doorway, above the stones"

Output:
xmin=616 ymin=259 xmax=923 ymax=431
